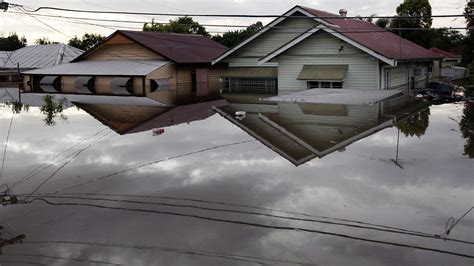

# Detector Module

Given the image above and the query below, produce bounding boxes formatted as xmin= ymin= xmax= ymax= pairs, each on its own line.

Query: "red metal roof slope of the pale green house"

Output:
xmin=301 ymin=7 xmax=442 ymax=60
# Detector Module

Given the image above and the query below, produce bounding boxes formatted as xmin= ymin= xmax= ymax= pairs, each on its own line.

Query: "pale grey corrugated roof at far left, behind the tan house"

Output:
xmin=0 ymin=44 xmax=84 ymax=69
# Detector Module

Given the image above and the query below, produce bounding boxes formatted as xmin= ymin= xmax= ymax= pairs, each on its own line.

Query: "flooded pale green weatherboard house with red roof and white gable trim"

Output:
xmin=214 ymin=6 xmax=440 ymax=94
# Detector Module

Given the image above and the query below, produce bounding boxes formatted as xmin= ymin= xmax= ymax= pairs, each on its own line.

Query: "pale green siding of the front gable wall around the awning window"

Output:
xmin=278 ymin=32 xmax=379 ymax=94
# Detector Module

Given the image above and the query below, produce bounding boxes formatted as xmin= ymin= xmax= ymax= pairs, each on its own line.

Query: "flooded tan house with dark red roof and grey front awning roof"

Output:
xmin=24 ymin=31 xmax=227 ymax=105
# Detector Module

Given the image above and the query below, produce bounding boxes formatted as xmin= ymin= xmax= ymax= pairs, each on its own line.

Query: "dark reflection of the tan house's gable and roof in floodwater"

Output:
xmin=75 ymin=100 xmax=228 ymax=135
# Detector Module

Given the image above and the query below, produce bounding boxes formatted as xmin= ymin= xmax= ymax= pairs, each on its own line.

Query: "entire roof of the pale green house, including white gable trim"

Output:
xmin=214 ymin=6 xmax=440 ymax=65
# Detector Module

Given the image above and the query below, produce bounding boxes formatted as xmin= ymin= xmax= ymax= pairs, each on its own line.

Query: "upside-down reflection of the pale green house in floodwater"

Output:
xmin=216 ymin=96 xmax=424 ymax=165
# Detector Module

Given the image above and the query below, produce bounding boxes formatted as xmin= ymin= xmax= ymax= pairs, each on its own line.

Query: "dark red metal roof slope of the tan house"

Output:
xmin=119 ymin=31 xmax=228 ymax=64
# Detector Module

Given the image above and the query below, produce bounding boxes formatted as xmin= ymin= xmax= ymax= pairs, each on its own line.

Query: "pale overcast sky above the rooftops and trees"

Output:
xmin=0 ymin=0 xmax=467 ymax=44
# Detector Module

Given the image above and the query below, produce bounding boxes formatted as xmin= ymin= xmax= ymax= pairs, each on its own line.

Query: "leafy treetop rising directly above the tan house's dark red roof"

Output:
xmin=143 ymin=16 xmax=210 ymax=37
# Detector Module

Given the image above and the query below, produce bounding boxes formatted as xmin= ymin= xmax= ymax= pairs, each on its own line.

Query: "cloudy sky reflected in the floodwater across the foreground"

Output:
xmin=0 ymin=101 xmax=474 ymax=265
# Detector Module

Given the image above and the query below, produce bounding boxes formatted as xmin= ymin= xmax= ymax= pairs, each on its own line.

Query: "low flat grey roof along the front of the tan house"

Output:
xmin=23 ymin=60 xmax=169 ymax=76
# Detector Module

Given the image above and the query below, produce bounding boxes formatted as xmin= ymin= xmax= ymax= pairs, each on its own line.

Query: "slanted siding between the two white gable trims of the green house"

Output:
xmin=224 ymin=15 xmax=318 ymax=67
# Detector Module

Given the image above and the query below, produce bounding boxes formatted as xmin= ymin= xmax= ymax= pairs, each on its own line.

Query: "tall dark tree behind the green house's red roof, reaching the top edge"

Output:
xmin=390 ymin=0 xmax=433 ymax=48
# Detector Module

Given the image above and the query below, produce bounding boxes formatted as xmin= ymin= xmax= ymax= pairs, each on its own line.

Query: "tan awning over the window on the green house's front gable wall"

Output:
xmin=298 ymin=65 xmax=349 ymax=80
